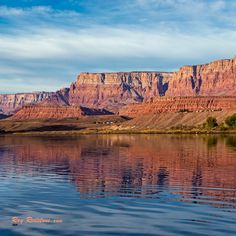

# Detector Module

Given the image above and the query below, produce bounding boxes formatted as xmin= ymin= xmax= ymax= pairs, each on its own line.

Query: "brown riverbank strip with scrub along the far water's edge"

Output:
xmin=0 ymin=113 xmax=236 ymax=135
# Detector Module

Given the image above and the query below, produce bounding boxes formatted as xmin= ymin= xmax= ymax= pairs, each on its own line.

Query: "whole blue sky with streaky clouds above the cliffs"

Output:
xmin=0 ymin=0 xmax=236 ymax=93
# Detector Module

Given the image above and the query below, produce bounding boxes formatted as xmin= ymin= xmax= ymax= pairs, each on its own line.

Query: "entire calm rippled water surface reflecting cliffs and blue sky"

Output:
xmin=0 ymin=135 xmax=236 ymax=236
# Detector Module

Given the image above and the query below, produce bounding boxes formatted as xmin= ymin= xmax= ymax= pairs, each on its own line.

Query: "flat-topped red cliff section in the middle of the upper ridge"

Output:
xmin=69 ymin=72 xmax=172 ymax=110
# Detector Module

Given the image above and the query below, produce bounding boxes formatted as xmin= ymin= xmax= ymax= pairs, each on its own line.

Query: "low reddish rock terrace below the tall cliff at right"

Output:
xmin=120 ymin=97 xmax=236 ymax=117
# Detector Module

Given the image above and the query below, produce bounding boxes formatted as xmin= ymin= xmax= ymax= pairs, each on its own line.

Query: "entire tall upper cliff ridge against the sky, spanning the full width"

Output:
xmin=0 ymin=57 xmax=236 ymax=114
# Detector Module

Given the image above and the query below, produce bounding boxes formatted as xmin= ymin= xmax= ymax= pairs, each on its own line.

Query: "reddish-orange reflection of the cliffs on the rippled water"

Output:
xmin=0 ymin=135 xmax=236 ymax=205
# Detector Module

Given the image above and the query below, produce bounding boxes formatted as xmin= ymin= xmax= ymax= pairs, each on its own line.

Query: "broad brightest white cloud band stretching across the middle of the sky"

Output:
xmin=0 ymin=27 xmax=236 ymax=60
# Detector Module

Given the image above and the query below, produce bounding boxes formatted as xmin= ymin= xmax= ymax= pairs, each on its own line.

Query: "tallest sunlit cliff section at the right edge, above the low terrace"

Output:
xmin=166 ymin=57 xmax=236 ymax=96
